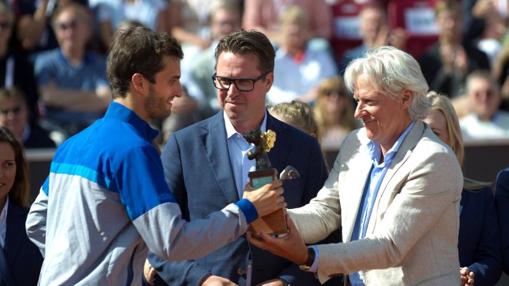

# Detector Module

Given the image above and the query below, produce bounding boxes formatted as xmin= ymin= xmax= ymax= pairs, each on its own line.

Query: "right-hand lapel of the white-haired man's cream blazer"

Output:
xmin=367 ymin=121 xmax=425 ymax=233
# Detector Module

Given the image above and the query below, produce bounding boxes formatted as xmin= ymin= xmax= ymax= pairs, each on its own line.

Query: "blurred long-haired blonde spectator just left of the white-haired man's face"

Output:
xmin=314 ymin=76 xmax=359 ymax=151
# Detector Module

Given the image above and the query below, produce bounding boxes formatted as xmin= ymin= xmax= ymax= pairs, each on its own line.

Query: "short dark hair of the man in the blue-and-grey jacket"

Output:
xmin=107 ymin=25 xmax=184 ymax=98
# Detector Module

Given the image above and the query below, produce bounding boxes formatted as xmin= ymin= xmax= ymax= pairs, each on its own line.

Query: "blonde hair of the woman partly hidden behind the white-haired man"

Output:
xmin=426 ymin=91 xmax=465 ymax=165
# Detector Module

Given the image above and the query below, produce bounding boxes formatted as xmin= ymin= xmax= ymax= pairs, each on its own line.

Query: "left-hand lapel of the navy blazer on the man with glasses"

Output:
xmin=202 ymin=111 xmax=239 ymax=202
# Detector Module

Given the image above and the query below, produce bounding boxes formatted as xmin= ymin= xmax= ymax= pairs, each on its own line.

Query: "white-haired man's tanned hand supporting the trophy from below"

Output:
xmin=247 ymin=216 xmax=308 ymax=265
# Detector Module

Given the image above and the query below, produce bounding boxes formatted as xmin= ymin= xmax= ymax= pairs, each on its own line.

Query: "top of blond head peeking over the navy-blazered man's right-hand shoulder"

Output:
xmin=269 ymin=100 xmax=318 ymax=138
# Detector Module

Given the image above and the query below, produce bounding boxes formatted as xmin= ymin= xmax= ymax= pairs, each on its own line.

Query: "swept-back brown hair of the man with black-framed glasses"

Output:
xmin=215 ymin=30 xmax=276 ymax=73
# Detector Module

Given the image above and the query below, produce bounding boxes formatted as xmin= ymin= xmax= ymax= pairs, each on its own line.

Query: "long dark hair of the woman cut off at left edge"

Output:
xmin=0 ymin=127 xmax=29 ymax=207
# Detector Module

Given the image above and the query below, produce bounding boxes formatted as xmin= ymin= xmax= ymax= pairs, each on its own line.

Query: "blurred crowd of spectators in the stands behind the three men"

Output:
xmin=0 ymin=0 xmax=509 ymax=150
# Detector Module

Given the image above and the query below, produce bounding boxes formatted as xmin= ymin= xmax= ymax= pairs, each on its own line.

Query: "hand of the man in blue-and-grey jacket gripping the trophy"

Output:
xmin=243 ymin=180 xmax=286 ymax=217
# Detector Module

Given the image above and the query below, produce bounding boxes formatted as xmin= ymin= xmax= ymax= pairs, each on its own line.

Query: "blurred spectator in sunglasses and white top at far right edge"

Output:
xmin=460 ymin=71 xmax=509 ymax=141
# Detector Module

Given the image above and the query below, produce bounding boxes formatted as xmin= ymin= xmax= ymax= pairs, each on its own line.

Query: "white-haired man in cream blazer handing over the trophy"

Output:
xmin=250 ymin=47 xmax=463 ymax=286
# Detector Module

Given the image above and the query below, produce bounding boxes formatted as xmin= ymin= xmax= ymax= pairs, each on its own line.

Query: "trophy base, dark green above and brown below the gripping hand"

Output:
xmin=248 ymin=168 xmax=288 ymax=237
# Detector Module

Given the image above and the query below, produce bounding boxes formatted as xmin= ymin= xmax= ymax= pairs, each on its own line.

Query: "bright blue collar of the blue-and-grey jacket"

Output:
xmin=104 ymin=101 xmax=159 ymax=141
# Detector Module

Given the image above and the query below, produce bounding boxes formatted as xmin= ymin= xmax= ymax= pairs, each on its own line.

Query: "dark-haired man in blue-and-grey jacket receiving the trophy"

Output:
xmin=26 ymin=26 xmax=285 ymax=285
